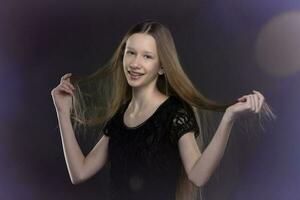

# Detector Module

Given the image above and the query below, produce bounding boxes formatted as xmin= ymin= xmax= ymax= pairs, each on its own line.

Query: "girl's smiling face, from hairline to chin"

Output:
xmin=123 ymin=33 xmax=160 ymax=87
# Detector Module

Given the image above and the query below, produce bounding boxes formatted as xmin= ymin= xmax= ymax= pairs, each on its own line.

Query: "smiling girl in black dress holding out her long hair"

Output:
xmin=51 ymin=20 xmax=272 ymax=200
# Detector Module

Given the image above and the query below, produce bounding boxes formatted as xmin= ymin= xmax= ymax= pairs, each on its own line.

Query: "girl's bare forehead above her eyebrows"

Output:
xmin=126 ymin=33 xmax=156 ymax=52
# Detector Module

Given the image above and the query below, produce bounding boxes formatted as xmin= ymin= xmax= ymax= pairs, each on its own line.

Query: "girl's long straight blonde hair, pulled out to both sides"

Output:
xmin=71 ymin=20 xmax=276 ymax=200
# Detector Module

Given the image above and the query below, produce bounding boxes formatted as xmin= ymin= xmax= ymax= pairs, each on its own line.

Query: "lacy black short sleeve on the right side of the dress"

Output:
xmin=170 ymin=108 xmax=199 ymax=145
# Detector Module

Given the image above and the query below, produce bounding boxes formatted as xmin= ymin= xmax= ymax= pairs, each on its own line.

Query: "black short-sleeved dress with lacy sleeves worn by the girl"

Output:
xmin=103 ymin=96 xmax=199 ymax=200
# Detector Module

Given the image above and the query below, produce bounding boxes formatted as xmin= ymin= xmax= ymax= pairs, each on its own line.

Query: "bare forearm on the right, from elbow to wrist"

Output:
xmin=190 ymin=112 xmax=234 ymax=186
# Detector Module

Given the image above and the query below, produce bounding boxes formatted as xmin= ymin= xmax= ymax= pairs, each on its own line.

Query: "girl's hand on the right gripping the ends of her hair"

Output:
xmin=225 ymin=90 xmax=265 ymax=119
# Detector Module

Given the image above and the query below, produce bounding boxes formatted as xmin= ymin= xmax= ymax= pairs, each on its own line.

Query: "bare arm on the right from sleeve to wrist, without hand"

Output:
xmin=178 ymin=113 xmax=234 ymax=187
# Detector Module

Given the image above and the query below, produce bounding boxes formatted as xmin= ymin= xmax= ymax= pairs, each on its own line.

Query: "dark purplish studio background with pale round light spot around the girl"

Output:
xmin=0 ymin=0 xmax=300 ymax=200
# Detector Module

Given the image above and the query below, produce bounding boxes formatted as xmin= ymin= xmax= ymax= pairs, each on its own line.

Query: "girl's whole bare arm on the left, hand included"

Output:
xmin=51 ymin=73 xmax=109 ymax=184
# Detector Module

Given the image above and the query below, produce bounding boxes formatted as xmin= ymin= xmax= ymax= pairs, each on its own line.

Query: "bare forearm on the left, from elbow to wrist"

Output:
xmin=57 ymin=112 xmax=84 ymax=183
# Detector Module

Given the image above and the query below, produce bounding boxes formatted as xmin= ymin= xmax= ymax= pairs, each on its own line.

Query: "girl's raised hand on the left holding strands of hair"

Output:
xmin=51 ymin=73 xmax=75 ymax=113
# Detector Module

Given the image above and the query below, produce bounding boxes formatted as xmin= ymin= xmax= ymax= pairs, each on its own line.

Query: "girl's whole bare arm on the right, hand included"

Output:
xmin=178 ymin=91 xmax=264 ymax=187
